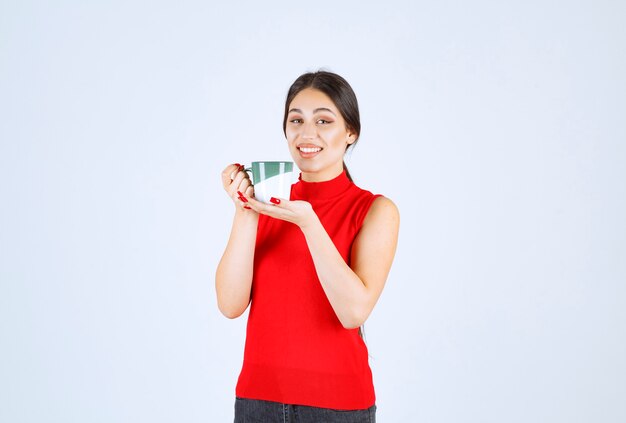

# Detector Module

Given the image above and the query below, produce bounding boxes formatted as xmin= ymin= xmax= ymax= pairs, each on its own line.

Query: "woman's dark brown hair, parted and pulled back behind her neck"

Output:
xmin=283 ymin=71 xmax=361 ymax=180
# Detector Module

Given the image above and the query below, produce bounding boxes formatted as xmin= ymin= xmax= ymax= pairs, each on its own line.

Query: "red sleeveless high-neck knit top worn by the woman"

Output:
xmin=236 ymin=172 xmax=377 ymax=410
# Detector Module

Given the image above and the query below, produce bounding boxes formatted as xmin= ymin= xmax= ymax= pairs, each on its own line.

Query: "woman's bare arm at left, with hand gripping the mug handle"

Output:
xmin=215 ymin=165 xmax=259 ymax=319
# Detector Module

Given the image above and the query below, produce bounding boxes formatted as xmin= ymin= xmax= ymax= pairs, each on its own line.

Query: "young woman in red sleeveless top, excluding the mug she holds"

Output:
xmin=215 ymin=71 xmax=399 ymax=423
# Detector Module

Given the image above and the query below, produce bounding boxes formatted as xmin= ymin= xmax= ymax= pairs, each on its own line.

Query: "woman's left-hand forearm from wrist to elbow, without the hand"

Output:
xmin=215 ymin=209 xmax=258 ymax=318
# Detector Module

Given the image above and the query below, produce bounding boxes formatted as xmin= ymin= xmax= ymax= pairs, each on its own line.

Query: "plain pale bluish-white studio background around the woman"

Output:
xmin=0 ymin=0 xmax=626 ymax=423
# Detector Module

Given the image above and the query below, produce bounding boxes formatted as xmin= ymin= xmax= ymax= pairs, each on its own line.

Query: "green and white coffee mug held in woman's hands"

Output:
xmin=246 ymin=162 xmax=293 ymax=204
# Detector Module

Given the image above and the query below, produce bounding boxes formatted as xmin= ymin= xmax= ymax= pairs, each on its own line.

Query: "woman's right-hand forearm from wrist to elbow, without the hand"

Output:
xmin=301 ymin=218 xmax=371 ymax=328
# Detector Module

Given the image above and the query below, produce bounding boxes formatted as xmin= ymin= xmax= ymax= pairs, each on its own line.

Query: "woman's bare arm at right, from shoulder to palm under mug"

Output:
xmin=241 ymin=197 xmax=400 ymax=329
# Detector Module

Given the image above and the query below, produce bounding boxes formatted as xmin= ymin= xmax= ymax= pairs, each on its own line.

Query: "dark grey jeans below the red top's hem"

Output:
xmin=235 ymin=398 xmax=376 ymax=423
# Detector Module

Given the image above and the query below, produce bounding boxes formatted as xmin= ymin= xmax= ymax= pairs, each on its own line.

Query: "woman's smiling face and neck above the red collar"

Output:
xmin=285 ymin=88 xmax=356 ymax=182
